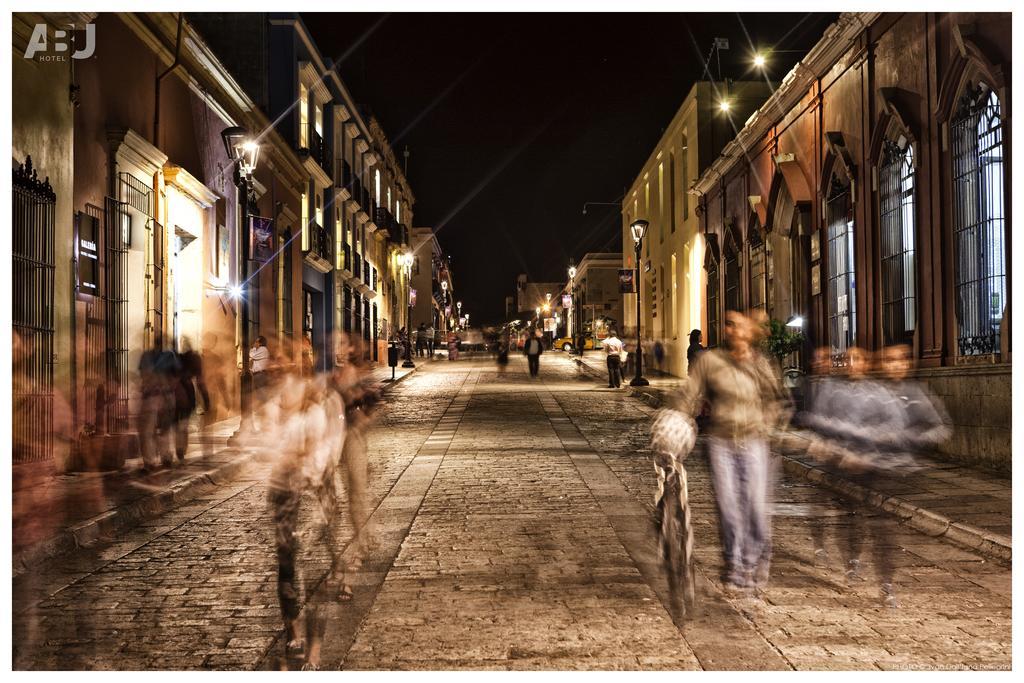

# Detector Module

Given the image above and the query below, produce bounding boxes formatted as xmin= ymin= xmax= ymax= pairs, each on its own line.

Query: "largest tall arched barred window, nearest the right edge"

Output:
xmin=949 ymin=84 xmax=1007 ymax=355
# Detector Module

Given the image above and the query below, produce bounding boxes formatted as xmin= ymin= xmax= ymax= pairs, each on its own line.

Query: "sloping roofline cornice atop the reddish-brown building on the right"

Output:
xmin=690 ymin=12 xmax=882 ymax=195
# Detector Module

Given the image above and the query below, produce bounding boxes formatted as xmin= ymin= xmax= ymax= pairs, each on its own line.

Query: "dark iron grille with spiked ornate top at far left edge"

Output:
xmin=11 ymin=157 xmax=57 ymax=464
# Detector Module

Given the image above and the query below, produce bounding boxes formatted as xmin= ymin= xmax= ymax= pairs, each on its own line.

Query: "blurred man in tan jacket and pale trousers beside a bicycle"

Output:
xmin=672 ymin=310 xmax=784 ymax=590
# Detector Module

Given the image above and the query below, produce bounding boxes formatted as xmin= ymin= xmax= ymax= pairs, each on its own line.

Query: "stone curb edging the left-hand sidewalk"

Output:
xmin=11 ymin=368 xmax=417 ymax=577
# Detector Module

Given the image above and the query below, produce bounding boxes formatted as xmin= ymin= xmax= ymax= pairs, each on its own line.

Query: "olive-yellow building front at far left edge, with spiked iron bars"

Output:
xmin=8 ymin=12 xmax=81 ymax=481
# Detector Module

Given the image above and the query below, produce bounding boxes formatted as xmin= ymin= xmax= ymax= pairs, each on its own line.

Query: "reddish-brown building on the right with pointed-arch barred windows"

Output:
xmin=694 ymin=12 xmax=1011 ymax=471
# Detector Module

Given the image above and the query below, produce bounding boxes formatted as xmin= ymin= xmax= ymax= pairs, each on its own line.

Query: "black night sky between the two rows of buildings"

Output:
xmin=303 ymin=13 xmax=837 ymax=324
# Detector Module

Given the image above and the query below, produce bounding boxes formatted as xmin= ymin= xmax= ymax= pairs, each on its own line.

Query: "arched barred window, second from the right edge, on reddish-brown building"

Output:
xmin=879 ymin=135 xmax=916 ymax=346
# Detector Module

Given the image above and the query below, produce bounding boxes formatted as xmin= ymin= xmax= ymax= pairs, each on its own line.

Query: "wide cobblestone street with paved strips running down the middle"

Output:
xmin=13 ymin=352 xmax=1011 ymax=670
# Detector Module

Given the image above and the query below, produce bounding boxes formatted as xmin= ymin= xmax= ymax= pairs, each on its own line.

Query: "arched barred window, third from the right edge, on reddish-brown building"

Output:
xmin=825 ymin=175 xmax=857 ymax=365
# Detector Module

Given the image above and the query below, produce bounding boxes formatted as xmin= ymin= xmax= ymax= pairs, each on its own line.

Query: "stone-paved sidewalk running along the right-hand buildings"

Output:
xmin=570 ymin=353 xmax=1013 ymax=561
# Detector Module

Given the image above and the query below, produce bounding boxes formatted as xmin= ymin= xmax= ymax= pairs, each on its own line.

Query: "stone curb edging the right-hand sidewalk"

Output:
xmin=573 ymin=359 xmax=1013 ymax=562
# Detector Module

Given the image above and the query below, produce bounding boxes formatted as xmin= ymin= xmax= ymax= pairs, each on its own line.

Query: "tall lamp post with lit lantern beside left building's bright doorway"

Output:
xmin=220 ymin=126 xmax=259 ymax=442
